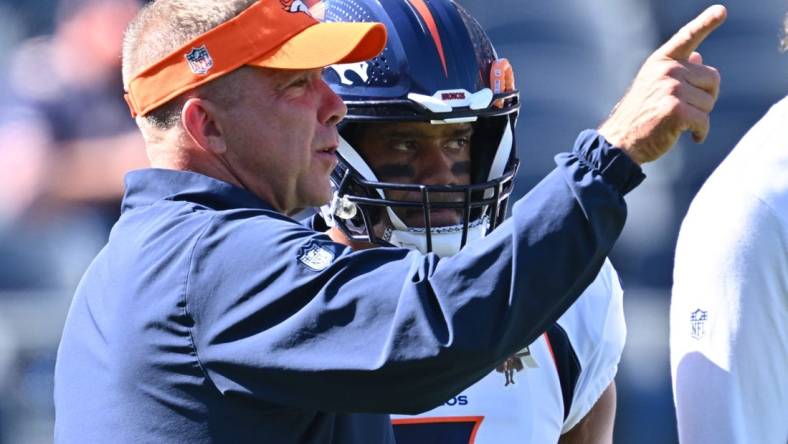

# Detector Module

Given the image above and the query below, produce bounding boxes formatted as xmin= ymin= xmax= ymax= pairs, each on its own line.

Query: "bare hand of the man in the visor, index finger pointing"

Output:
xmin=599 ymin=5 xmax=727 ymax=164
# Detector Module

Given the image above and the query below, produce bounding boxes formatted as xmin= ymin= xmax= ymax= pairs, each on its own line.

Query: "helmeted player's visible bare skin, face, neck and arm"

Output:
xmin=328 ymin=122 xmax=616 ymax=444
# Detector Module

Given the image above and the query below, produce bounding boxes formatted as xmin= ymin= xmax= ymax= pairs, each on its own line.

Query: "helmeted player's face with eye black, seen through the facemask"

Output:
xmin=354 ymin=122 xmax=473 ymax=227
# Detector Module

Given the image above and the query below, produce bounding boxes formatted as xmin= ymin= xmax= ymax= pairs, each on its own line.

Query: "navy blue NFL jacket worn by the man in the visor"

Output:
xmin=55 ymin=131 xmax=643 ymax=444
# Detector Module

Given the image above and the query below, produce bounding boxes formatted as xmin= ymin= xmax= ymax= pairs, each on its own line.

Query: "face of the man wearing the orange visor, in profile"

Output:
xmin=222 ymin=68 xmax=346 ymax=214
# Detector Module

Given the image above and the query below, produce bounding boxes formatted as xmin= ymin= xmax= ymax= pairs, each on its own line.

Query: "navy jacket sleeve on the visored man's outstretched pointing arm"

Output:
xmin=186 ymin=131 xmax=643 ymax=413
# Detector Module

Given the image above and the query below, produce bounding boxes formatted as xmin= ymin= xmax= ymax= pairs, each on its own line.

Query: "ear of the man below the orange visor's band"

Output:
xmin=181 ymin=97 xmax=227 ymax=154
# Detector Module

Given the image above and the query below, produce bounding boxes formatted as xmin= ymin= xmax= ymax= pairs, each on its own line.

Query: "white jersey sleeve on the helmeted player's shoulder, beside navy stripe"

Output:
xmin=558 ymin=260 xmax=627 ymax=434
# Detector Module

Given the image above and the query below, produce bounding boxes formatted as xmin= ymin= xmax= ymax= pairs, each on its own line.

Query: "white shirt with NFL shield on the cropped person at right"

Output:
xmin=670 ymin=98 xmax=788 ymax=444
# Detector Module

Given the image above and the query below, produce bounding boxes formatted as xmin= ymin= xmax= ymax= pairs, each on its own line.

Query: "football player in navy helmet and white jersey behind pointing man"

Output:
xmin=322 ymin=0 xmax=626 ymax=444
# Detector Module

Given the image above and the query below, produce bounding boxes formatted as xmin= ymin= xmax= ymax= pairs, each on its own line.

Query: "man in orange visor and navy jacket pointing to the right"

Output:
xmin=55 ymin=0 xmax=725 ymax=444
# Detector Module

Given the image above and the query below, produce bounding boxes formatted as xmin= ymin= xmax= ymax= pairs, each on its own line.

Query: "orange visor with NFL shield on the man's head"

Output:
xmin=125 ymin=0 xmax=386 ymax=117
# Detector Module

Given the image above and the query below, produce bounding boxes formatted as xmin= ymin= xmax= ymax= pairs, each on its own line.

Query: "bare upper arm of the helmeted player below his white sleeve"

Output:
xmin=558 ymin=381 xmax=616 ymax=444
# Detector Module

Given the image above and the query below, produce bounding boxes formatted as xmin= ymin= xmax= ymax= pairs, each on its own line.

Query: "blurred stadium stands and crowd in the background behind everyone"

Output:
xmin=0 ymin=0 xmax=788 ymax=444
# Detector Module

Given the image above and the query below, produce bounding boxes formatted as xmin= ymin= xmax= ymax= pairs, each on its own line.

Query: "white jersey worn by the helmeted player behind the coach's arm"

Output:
xmin=392 ymin=261 xmax=626 ymax=444
